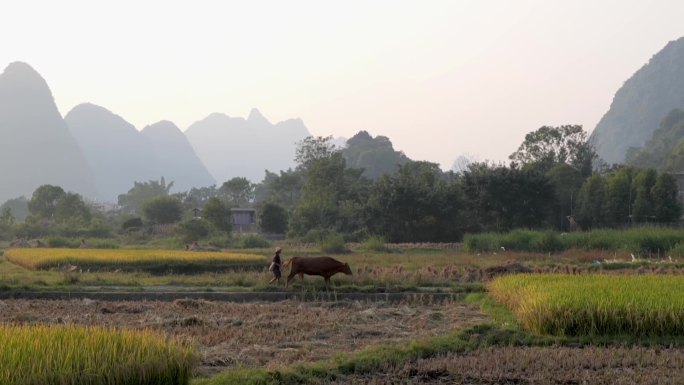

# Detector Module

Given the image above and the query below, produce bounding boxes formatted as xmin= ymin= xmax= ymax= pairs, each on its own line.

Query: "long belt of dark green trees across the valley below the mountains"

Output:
xmin=0 ymin=125 xmax=682 ymax=242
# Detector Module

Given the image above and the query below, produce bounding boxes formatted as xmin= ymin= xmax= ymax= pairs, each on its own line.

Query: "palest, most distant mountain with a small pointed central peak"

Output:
xmin=185 ymin=109 xmax=310 ymax=185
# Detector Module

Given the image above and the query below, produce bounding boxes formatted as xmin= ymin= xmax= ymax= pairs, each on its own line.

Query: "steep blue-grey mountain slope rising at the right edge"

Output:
xmin=591 ymin=37 xmax=684 ymax=163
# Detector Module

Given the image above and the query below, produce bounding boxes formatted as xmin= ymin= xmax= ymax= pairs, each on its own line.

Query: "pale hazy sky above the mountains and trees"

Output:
xmin=0 ymin=0 xmax=684 ymax=169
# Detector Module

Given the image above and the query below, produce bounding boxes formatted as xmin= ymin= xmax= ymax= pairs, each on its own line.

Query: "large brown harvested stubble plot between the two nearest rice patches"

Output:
xmin=0 ymin=300 xmax=488 ymax=374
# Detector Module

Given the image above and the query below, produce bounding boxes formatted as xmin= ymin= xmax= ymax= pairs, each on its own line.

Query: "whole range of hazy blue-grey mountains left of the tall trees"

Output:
xmin=0 ymin=62 xmax=310 ymax=203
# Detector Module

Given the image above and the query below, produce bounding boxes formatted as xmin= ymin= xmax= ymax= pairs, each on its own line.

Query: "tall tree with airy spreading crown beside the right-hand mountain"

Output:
xmin=509 ymin=125 xmax=597 ymax=177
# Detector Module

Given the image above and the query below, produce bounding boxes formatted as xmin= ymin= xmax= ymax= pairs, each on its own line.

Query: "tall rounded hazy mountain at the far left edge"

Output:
xmin=0 ymin=62 xmax=95 ymax=202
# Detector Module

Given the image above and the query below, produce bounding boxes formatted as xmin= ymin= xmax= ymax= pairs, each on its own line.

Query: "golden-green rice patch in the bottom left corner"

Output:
xmin=0 ymin=325 xmax=197 ymax=385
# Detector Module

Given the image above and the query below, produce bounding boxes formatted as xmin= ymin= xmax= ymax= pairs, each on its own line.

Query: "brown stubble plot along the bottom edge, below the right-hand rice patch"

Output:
xmin=332 ymin=347 xmax=684 ymax=385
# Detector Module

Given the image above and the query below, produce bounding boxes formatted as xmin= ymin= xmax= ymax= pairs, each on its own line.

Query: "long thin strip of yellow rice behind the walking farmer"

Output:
xmin=5 ymin=248 xmax=266 ymax=270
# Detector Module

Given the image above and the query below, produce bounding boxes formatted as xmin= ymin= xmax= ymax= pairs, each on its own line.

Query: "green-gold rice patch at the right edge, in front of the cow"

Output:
xmin=488 ymin=274 xmax=684 ymax=336
